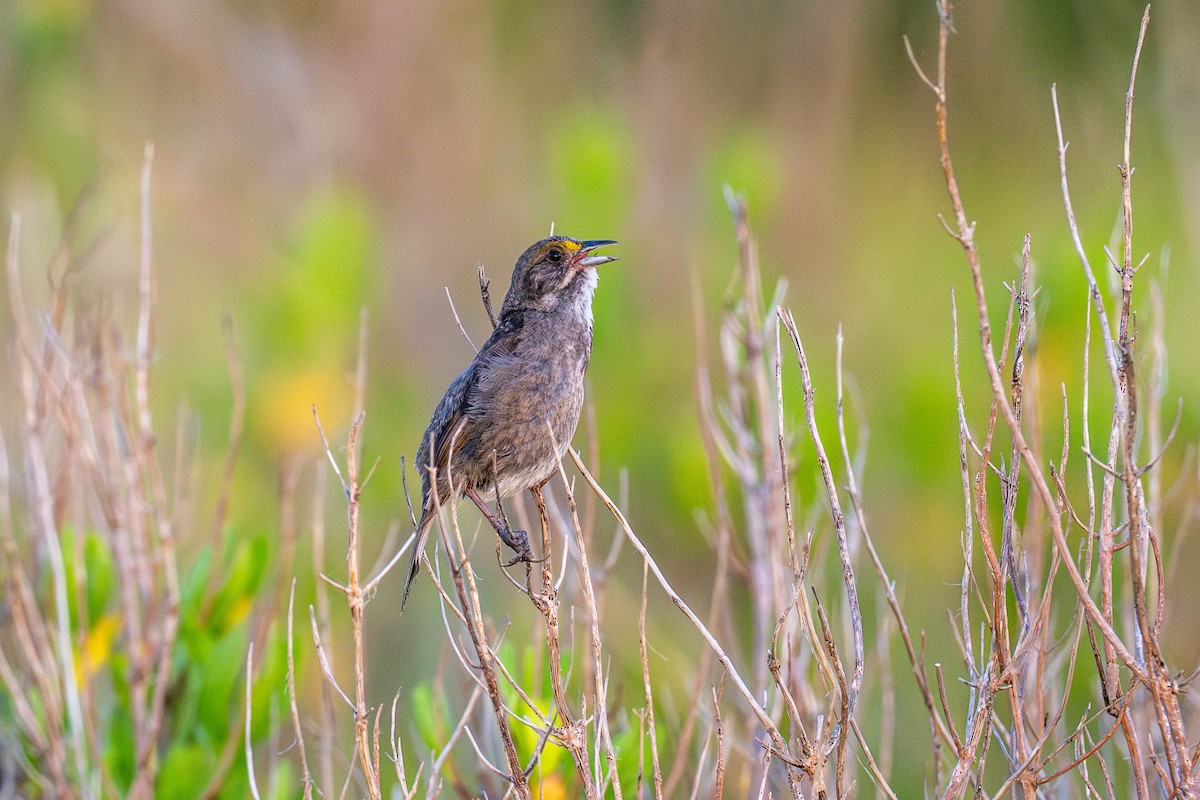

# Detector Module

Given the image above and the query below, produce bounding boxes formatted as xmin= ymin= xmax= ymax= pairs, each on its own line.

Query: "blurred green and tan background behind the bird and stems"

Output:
xmin=0 ymin=0 xmax=1200 ymax=787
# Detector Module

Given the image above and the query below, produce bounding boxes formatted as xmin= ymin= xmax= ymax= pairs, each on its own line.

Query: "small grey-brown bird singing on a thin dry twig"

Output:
xmin=400 ymin=236 xmax=617 ymax=612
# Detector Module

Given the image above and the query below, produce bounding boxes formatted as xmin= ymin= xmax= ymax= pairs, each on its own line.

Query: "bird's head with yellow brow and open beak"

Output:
xmin=500 ymin=236 xmax=617 ymax=313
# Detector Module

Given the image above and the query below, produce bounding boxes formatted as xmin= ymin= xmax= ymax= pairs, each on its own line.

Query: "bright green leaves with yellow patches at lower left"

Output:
xmin=11 ymin=529 xmax=287 ymax=799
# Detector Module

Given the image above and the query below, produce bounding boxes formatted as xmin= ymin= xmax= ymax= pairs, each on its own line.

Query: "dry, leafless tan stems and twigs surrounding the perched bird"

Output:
xmin=0 ymin=6 xmax=1200 ymax=800
